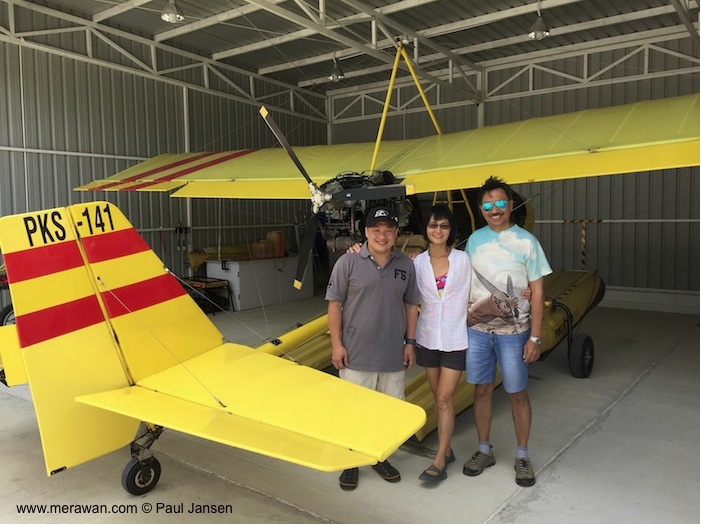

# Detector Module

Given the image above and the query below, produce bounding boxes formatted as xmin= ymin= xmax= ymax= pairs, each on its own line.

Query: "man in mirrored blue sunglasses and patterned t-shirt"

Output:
xmin=463 ymin=177 xmax=552 ymax=487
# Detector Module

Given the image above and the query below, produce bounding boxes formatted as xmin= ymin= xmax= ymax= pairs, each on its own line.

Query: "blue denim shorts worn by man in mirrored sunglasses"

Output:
xmin=466 ymin=328 xmax=530 ymax=394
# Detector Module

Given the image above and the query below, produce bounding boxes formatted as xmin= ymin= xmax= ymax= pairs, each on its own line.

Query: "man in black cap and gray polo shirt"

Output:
xmin=326 ymin=207 xmax=420 ymax=490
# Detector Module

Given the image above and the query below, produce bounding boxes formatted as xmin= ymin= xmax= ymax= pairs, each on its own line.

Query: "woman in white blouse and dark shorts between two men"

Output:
xmin=414 ymin=205 xmax=472 ymax=483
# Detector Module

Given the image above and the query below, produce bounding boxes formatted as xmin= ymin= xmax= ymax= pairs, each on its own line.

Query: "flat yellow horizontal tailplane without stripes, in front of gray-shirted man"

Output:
xmin=78 ymin=343 xmax=426 ymax=471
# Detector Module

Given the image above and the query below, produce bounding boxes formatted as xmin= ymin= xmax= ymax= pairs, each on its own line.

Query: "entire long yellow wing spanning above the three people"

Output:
xmin=77 ymin=95 xmax=699 ymax=199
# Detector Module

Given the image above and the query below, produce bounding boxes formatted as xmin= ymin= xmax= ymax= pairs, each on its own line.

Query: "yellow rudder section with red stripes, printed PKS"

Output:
xmin=0 ymin=208 xmax=147 ymax=474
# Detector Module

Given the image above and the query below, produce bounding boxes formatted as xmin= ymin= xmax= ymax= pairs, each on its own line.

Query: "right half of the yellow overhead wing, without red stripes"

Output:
xmin=394 ymin=95 xmax=699 ymax=193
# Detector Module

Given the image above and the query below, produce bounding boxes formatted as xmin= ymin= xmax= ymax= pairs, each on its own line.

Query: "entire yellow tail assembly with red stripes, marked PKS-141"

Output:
xmin=0 ymin=202 xmax=426 ymax=474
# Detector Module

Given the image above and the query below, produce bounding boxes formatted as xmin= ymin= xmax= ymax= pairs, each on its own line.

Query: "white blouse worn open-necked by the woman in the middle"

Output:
xmin=414 ymin=248 xmax=472 ymax=351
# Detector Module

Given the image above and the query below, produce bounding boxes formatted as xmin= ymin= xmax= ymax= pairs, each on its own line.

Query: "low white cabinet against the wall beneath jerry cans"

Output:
xmin=207 ymin=256 xmax=314 ymax=311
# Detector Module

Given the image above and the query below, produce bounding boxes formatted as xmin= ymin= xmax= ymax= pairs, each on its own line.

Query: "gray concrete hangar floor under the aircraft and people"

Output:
xmin=0 ymin=297 xmax=700 ymax=523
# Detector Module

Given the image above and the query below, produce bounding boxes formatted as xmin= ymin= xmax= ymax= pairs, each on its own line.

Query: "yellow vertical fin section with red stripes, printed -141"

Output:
xmin=64 ymin=202 xmax=223 ymax=383
